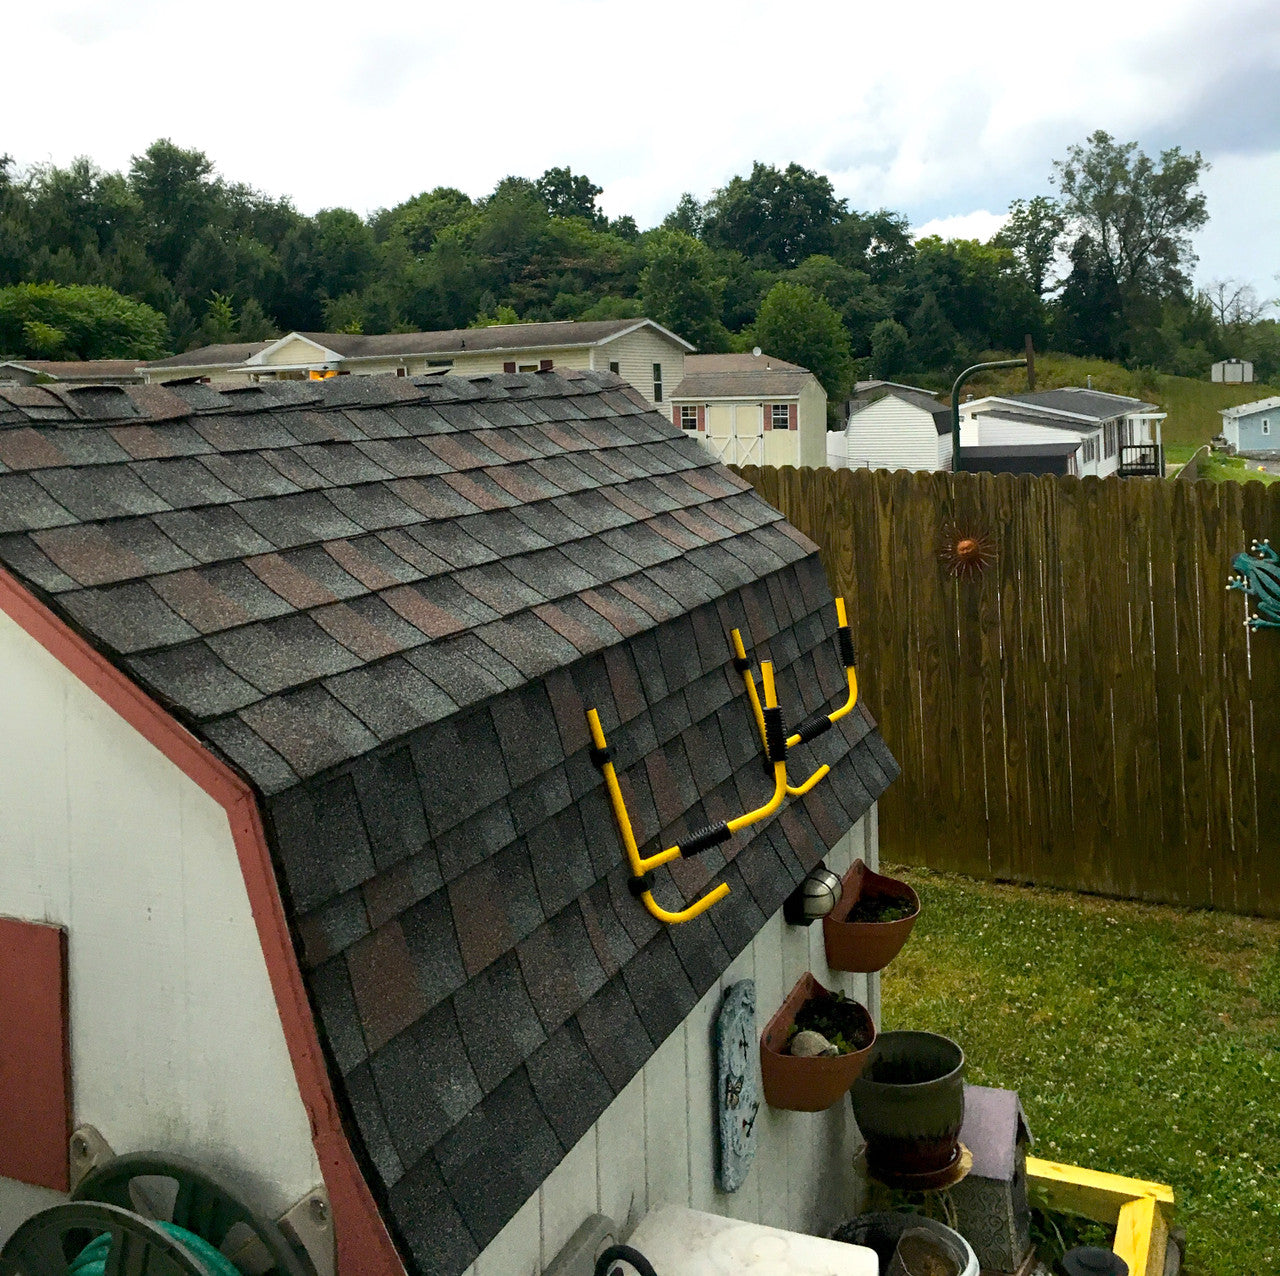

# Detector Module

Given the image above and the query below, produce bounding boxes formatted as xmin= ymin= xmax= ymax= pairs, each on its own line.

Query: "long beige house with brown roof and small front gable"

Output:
xmin=142 ymin=319 xmax=694 ymax=407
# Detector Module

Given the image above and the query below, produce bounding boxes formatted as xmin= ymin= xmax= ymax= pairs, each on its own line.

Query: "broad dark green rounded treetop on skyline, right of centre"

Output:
xmin=703 ymin=163 xmax=846 ymax=266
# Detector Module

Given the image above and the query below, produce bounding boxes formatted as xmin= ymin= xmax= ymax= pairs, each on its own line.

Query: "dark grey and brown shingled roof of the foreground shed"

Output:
xmin=0 ymin=372 xmax=897 ymax=1273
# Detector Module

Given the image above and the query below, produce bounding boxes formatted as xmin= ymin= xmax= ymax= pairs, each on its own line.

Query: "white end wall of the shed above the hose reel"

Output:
xmin=0 ymin=612 xmax=320 ymax=1240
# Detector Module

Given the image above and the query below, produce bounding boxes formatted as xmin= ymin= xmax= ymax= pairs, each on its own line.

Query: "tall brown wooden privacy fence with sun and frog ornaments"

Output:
xmin=740 ymin=466 xmax=1280 ymax=915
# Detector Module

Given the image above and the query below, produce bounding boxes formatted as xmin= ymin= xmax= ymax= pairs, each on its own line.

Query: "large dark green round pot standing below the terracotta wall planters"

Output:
xmin=849 ymin=1033 xmax=964 ymax=1176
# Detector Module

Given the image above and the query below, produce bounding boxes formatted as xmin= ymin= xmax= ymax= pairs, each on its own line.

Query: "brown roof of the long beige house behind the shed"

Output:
xmin=142 ymin=319 xmax=694 ymax=369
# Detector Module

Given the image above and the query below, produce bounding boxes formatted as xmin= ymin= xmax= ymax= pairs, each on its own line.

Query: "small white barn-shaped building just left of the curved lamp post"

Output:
xmin=827 ymin=381 xmax=951 ymax=471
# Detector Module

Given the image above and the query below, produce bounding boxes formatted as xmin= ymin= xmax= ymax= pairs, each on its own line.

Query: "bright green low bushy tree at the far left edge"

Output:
xmin=0 ymin=284 xmax=168 ymax=360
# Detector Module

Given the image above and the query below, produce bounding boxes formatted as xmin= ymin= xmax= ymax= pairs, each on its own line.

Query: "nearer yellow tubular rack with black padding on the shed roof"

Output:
xmin=586 ymin=660 xmax=788 ymax=925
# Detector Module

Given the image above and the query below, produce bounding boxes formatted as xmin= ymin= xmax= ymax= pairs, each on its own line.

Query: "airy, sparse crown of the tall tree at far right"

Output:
xmin=1055 ymin=129 xmax=1208 ymax=296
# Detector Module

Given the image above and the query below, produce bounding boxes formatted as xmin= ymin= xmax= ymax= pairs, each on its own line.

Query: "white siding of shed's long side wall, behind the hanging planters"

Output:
xmin=468 ymin=808 xmax=879 ymax=1276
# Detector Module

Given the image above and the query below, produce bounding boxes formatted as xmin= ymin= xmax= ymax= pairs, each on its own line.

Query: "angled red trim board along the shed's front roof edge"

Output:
xmin=0 ymin=568 xmax=404 ymax=1276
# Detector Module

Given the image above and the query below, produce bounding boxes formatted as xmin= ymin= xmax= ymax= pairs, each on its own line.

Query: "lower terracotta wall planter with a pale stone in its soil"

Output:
xmin=760 ymin=970 xmax=876 ymax=1112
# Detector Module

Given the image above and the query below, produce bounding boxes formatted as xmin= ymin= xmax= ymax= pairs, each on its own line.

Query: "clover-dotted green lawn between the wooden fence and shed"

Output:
xmin=883 ymin=869 xmax=1280 ymax=1276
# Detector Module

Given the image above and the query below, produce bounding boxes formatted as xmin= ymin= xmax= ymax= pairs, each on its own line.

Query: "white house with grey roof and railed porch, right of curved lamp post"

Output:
xmin=960 ymin=385 xmax=1166 ymax=477
